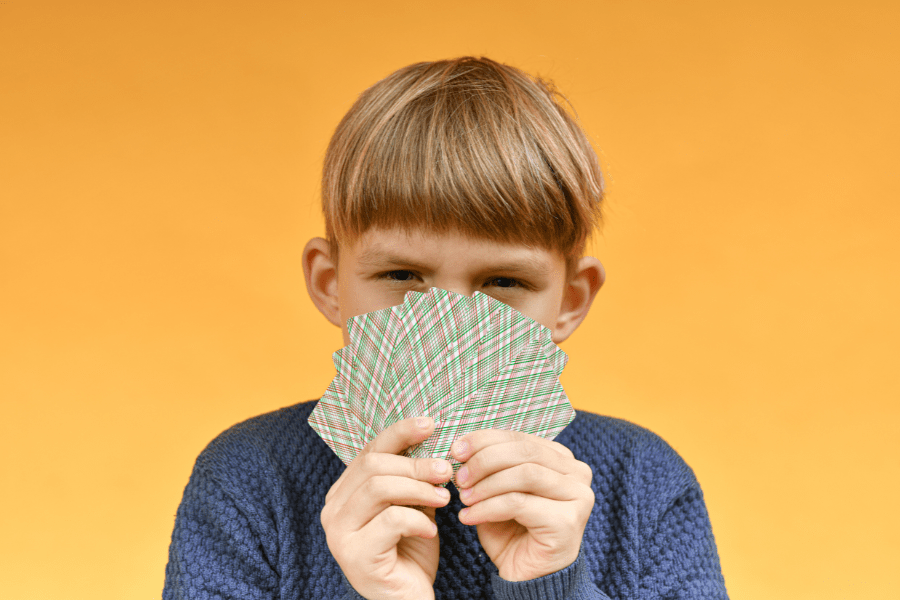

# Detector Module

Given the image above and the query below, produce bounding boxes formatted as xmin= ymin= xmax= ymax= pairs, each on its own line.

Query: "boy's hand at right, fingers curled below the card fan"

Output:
xmin=451 ymin=429 xmax=594 ymax=581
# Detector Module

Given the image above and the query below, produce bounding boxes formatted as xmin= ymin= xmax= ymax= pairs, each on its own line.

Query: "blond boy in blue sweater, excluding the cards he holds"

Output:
xmin=163 ymin=58 xmax=727 ymax=600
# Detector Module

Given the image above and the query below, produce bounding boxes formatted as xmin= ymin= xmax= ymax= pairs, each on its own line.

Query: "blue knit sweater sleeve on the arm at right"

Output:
xmin=532 ymin=413 xmax=728 ymax=600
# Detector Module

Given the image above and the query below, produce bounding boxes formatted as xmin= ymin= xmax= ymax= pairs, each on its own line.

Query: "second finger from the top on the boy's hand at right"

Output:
xmin=456 ymin=439 xmax=587 ymax=487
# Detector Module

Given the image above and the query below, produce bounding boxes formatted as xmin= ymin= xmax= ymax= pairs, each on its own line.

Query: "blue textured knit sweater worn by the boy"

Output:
xmin=163 ymin=401 xmax=727 ymax=600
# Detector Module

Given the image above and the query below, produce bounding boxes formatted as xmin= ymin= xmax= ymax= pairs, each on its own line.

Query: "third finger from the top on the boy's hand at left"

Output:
xmin=340 ymin=476 xmax=450 ymax=531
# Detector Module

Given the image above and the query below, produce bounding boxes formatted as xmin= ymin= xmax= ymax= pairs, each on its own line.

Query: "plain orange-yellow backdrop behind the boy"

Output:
xmin=0 ymin=0 xmax=900 ymax=600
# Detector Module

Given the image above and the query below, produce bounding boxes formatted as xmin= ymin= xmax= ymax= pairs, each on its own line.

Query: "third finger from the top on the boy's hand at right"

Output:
xmin=459 ymin=463 xmax=594 ymax=506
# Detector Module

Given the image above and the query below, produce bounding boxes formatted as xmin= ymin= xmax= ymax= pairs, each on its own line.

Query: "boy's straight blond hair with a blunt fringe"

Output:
xmin=322 ymin=57 xmax=603 ymax=269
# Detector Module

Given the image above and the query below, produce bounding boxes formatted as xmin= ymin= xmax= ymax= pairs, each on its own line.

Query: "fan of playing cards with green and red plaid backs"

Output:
xmin=309 ymin=288 xmax=575 ymax=474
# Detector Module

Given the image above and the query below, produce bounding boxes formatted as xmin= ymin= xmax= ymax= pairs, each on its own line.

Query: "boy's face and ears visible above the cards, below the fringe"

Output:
xmin=304 ymin=229 xmax=603 ymax=345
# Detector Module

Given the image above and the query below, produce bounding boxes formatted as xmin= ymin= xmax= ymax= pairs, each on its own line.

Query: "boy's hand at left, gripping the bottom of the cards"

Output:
xmin=321 ymin=417 xmax=452 ymax=600
